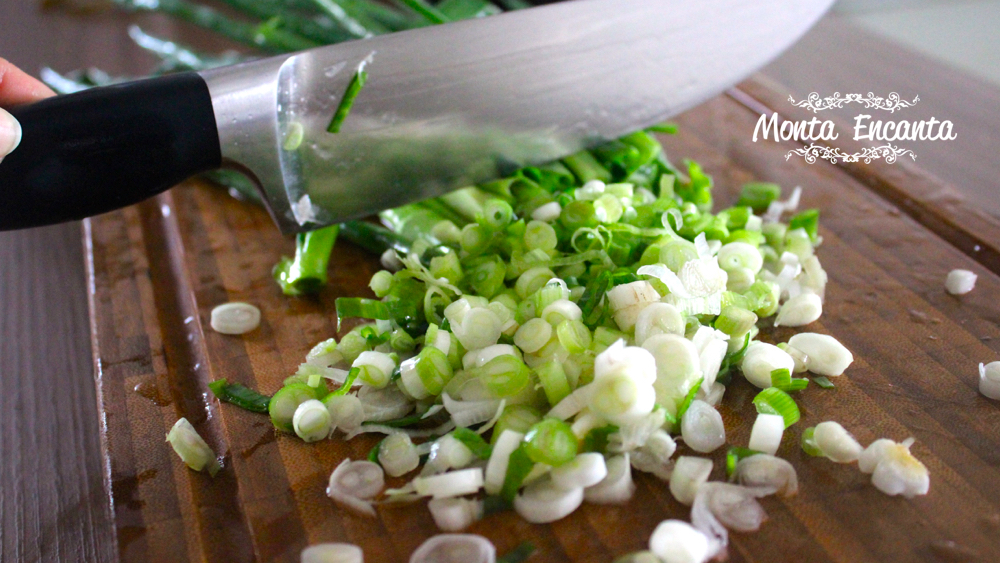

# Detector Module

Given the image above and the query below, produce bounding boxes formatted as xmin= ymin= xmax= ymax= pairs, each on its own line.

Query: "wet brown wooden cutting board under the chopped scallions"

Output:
xmin=85 ymin=79 xmax=1000 ymax=563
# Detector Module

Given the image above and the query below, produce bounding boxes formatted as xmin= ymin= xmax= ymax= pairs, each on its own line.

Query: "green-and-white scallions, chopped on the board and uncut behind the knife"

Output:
xmin=43 ymin=0 xmax=928 ymax=563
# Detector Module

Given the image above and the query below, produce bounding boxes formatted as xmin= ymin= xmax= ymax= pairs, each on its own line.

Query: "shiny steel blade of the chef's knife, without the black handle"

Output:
xmin=202 ymin=0 xmax=832 ymax=232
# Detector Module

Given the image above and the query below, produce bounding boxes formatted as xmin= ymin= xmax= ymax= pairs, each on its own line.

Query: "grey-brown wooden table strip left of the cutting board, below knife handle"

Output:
xmin=0 ymin=223 xmax=116 ymax=562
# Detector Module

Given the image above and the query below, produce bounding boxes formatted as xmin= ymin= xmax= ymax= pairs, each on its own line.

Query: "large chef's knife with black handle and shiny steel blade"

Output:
xmin=0 ymin=0 xmax=832 ymax=232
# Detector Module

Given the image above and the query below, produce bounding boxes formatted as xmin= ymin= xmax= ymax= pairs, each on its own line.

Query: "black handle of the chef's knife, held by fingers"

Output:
xmin=0 ymin=73 xmax=222 ymax=230
